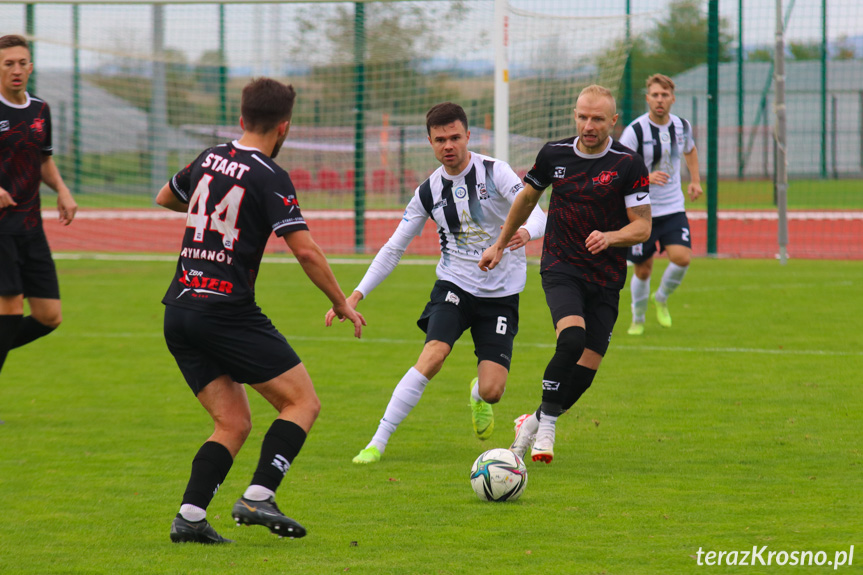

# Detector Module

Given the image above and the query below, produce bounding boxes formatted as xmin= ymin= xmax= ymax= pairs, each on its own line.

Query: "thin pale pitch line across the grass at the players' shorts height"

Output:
xmin=57 ymin=331 xmax=863 ymax=357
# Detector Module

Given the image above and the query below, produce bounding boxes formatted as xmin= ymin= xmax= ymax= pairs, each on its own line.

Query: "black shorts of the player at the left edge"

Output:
xmin=0 ymin=230 xmax=60 ymax=299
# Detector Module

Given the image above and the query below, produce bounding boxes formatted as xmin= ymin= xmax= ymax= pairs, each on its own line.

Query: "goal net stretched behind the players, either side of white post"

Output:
xmin=0 ymin=0 xmax=626 ymax=253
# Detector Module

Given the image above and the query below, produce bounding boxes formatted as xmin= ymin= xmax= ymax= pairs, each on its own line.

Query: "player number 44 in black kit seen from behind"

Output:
xmin=156 ymin=78 xmax=365 ymax=543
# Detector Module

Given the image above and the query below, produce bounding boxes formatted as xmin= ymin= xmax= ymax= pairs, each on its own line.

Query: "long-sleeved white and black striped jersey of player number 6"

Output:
xmin=356 ymin=152 xmax=546 ymax=298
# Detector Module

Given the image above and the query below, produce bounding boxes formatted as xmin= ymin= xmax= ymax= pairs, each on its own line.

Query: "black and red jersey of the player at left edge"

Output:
xmin=0 ymin=97 xmax=52 ymax=234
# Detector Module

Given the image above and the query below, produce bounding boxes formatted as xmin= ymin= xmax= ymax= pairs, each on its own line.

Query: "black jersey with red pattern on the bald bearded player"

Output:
xmin=525 ymin=138 xmax=648 ymax=289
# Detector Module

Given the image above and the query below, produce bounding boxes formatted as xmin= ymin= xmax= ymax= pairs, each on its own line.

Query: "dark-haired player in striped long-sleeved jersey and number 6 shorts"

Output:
xmin=327 ymin=102 xmax=545 ymax=463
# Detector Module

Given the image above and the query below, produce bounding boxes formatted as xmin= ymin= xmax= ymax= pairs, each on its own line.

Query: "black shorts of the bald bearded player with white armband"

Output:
xmin=542 ymin=272 xmax=620 ymax=356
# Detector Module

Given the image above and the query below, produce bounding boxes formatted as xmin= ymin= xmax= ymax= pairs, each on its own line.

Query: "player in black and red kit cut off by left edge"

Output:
xmin=0 ymin=35 xmax=78 ymax=378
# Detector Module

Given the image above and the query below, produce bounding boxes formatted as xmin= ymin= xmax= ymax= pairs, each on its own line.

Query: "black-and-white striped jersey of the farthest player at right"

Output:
xmin=620 ymin=114 xmax=695 ymax=217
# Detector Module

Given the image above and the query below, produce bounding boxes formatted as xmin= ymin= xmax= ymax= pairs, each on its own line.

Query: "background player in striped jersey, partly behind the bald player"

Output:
xmin=620 ymin=74 xmax=702 ymax=335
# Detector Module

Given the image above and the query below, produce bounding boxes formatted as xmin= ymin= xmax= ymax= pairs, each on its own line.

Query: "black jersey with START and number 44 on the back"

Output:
xmin=162 ymin=141 xmax=309 ymax=314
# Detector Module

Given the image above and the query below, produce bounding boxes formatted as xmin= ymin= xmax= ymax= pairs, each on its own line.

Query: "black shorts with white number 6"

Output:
xmin=417 ymin=280 xmax=518 ymax=369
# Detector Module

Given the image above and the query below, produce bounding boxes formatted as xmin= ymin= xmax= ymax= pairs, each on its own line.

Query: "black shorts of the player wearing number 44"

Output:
xmin=164 ymin=305 xmax=300 ymax=395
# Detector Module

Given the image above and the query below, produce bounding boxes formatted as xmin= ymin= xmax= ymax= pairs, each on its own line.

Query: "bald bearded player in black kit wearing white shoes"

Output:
xmin=479 ymin=85 xmax=651 ymax=463
